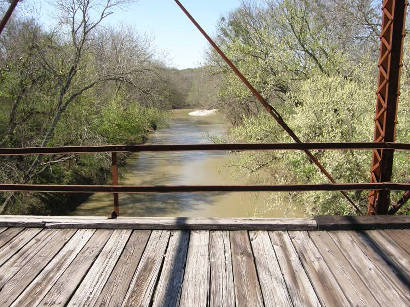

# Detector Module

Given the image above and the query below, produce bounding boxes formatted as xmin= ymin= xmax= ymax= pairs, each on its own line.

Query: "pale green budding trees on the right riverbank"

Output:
xmin=213 ymin=0 xmax=410 ymax=214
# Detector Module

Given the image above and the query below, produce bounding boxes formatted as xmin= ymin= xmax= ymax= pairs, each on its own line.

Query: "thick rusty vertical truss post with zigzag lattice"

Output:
xmin=368 ymin=0 xmax=407 ymax=215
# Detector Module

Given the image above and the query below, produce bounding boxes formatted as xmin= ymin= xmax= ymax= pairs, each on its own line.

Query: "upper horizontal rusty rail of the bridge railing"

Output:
xmin=0 ymin=143 xmax=410 ymax=156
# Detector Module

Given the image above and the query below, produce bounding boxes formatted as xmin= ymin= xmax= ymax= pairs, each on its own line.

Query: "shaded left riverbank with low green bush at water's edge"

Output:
xmin=0 ymin=107 xmax=166 ymax=215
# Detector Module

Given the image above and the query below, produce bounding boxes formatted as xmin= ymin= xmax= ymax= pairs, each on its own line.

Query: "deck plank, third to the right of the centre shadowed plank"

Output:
xmin=230 ymin=231 xmax=264 ymax=306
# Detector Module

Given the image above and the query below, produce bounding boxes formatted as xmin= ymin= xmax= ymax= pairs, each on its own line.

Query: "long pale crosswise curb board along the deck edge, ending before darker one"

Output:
xmin=0 ymin=216 xmax=317 ymax=230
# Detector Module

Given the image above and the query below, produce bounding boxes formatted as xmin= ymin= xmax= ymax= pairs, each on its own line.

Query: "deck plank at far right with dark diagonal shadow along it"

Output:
xmin=349 ymin=232 xmax=410 ymax=304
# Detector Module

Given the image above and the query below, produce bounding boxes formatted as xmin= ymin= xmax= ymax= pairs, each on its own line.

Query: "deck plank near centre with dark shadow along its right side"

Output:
xmin=152 ymin=231 xmax=189 ymax=307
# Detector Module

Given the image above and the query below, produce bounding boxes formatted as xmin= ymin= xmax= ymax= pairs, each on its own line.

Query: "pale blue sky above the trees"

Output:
xmin=16 ymin=0 xmax=241 ymax=69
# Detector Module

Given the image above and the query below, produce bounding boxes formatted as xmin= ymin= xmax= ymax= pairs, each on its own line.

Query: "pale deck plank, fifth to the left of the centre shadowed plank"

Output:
xmin=13 ymin=229 xmax=95 ymax=307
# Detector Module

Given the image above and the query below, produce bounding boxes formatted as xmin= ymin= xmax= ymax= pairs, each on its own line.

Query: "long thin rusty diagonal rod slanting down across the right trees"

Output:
xmin=174 ymin=0 xmax=362 ymax=214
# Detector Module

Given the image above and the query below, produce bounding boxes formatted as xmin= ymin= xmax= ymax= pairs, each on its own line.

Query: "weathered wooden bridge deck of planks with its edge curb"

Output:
xmin=0 ymin=217 xmax=410 ymax=306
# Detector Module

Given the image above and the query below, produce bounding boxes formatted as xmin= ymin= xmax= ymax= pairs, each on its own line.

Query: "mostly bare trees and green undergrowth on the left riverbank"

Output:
xmin=0 ymin=12 xmax=173 ymax=214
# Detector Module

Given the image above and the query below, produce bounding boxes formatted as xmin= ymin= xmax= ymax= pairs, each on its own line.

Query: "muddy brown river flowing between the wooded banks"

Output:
xmin=73 ymin=110 xmax=303 ymax=217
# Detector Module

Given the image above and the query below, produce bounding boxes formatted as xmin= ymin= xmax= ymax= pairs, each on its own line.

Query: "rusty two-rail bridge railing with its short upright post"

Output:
xmin=0 ymin=142 xmax=410 ymax=218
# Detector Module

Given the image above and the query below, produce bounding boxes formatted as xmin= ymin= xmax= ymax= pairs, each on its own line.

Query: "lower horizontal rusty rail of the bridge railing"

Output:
xmin=0 ymin=183 xmax=410 ymax=193
